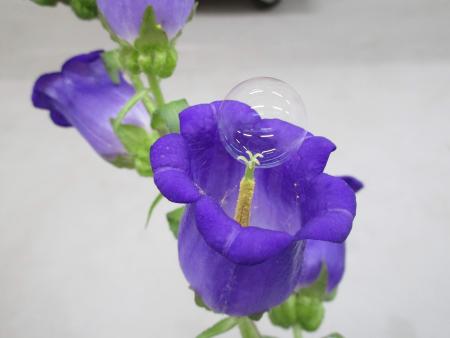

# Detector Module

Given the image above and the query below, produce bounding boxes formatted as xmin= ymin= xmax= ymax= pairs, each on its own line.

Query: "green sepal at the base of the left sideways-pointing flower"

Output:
xmin=111 ymin=119 xmax=158 ymax=176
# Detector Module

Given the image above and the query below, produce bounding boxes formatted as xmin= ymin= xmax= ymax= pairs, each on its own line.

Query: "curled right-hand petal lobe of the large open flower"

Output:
xmin=296 ymin=174 xmax=356 ymax=242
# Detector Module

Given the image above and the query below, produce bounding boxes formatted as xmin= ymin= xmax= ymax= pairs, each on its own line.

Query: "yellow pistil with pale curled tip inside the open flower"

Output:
xmin=234 ymin=150 xmax=263 ymax=227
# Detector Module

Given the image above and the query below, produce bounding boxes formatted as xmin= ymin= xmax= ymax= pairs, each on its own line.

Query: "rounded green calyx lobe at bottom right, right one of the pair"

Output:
xmin=296 ymin=294 xmax=325 ymax=332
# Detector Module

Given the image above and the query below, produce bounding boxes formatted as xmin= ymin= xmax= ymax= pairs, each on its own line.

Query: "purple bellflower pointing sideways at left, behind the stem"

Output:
xmin=32 ymin=51 xmax=150 ymax=162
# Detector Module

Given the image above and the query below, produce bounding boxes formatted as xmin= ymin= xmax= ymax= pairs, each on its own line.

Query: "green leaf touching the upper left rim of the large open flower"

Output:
xmin=152 ymin=99 xmax=188 ymax=133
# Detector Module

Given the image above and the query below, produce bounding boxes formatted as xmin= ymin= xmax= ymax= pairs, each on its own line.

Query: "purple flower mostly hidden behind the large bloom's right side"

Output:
xmin=299 ymin=176 xmax=363 ymax=292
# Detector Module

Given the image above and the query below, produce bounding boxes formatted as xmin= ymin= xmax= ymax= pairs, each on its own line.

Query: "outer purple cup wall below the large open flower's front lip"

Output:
xmin=178 ymin=206 xmax=303 ymax=316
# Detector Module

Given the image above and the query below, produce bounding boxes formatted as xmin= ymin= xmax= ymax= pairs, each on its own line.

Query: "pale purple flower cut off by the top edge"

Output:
xmin=97 ymin=0 xmax=194 ymax=42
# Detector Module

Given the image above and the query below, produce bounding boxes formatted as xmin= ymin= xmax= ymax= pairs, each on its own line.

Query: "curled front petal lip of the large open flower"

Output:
xmin=195 ymin=196 xmax=293 ymax=265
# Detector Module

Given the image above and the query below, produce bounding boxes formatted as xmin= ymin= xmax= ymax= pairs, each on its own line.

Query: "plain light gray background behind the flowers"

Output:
xmin=0 ymin=0 xmax=450 ymax=338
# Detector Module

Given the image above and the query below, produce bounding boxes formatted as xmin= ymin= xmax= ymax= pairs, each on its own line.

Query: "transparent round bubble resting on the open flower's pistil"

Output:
xmin=217 ymin=77 xmax=307 ymax=168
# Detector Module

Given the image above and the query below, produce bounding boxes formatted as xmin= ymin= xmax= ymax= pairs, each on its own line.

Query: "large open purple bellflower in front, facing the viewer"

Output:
xmin=150 ymin=102 xmax=356 ymax=316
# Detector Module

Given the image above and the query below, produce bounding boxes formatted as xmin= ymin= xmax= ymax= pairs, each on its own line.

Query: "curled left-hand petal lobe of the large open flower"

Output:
xmin=150 ymin=134 xmax=201 ymax=203
